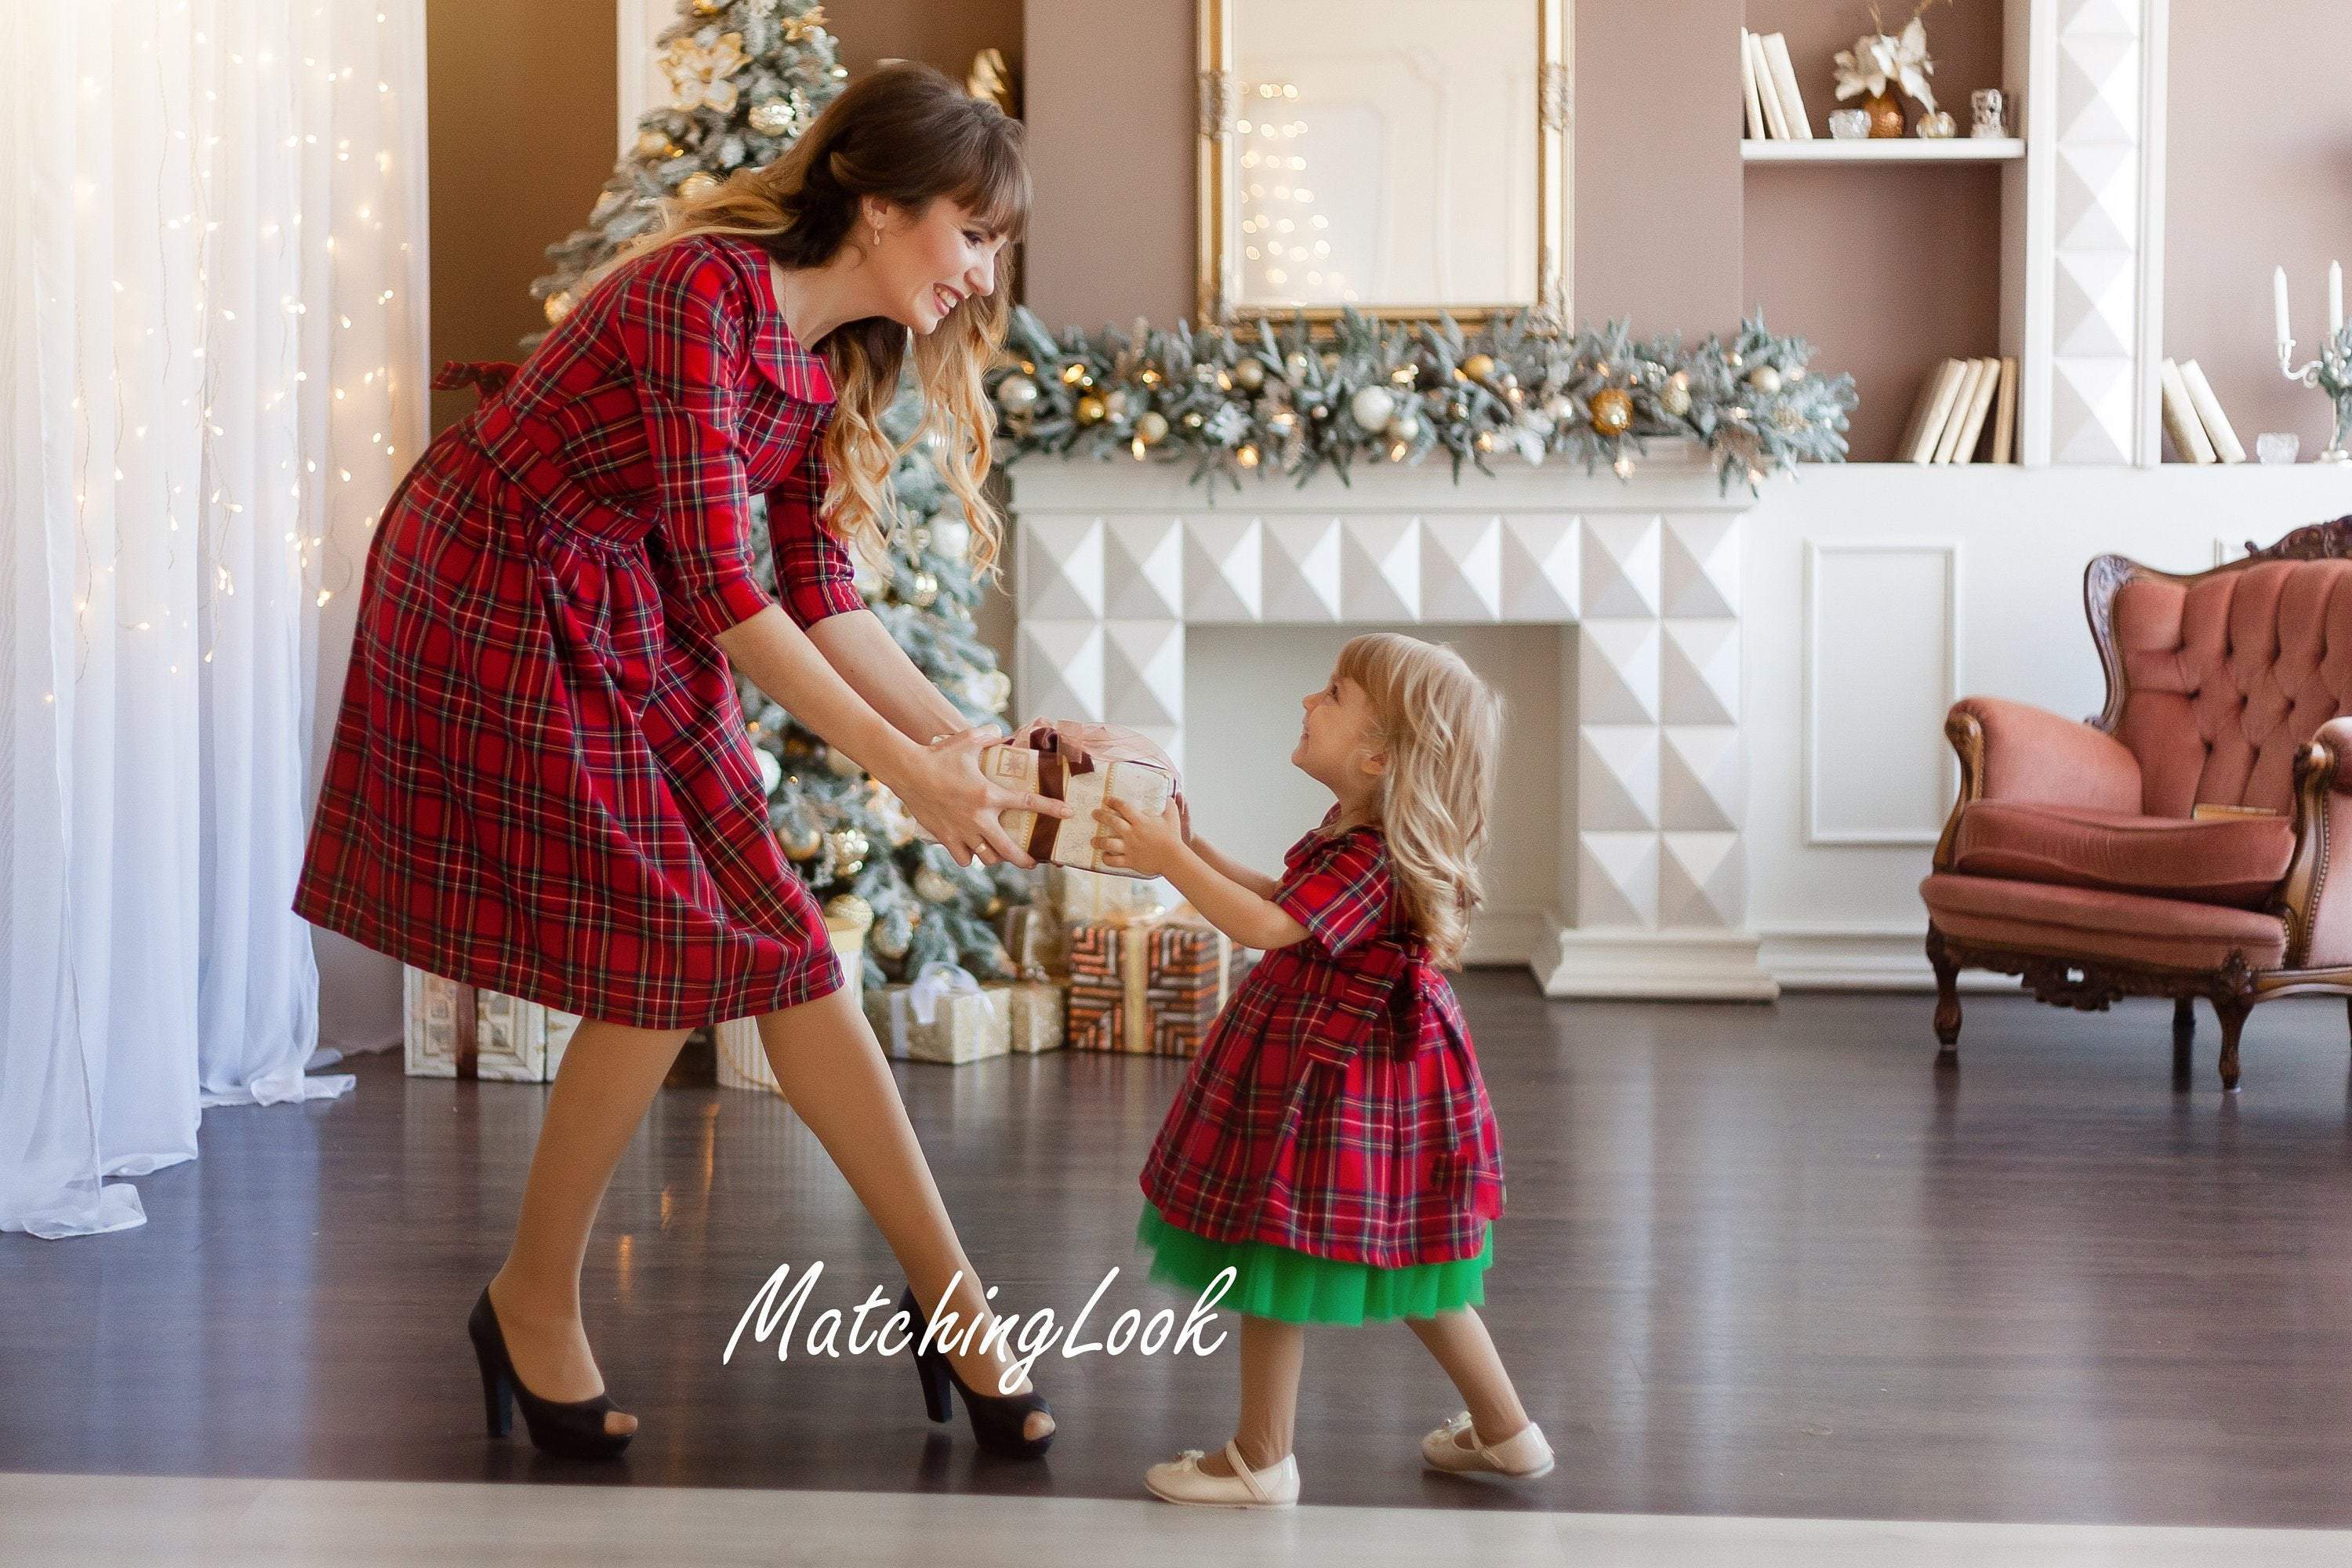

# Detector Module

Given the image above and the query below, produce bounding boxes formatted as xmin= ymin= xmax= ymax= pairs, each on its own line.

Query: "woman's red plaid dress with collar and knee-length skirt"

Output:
xmin=294 ymin=235 xmax=863 ymax=1029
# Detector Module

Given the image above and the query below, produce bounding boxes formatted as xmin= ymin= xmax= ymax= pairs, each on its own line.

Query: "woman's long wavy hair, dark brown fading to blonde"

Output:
xmin=576 ymin=61 xmax=1030 ymax=574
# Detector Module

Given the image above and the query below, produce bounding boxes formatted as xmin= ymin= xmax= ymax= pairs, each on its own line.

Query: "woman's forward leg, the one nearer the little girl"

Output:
xmin=760 ymin=987 xmax=1054 ymax=1439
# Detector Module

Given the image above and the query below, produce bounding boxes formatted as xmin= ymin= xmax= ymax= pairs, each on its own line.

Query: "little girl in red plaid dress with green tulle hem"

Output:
xmin=1096 ymin=633 xmax=1552 ymax=1507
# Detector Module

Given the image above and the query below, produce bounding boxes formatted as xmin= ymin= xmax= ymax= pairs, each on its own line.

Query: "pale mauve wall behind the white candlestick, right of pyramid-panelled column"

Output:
xmin=2164 ymin=0 xmax=2352 ymax=456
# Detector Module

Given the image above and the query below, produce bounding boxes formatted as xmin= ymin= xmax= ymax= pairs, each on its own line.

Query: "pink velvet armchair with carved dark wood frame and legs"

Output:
xmin=1919 ymin=517 xmax=2352 ymax=1091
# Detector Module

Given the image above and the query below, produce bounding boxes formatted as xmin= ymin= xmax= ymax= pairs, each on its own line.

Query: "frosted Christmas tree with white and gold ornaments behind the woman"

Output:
xmin=532 ymin=0 xmax=1035 ymax=985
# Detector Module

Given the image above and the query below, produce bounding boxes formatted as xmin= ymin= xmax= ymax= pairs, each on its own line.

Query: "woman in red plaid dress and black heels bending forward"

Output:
xmin=294 ymin=66 xmax=1070 ymax=1455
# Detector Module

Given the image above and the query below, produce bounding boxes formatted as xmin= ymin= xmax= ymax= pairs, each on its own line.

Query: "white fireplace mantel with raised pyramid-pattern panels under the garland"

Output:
xmin=1009 ymin=445 xmax=1776 ymax=999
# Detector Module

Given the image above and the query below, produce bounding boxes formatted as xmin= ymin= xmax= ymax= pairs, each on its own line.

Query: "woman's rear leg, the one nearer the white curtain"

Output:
xmin=489 ymin=1020 xmax=687 ymax=1434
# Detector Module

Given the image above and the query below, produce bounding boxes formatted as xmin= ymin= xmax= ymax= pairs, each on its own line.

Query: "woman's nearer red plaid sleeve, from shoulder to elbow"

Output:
xmin=616 ymin=242 xmax=774 ymax=637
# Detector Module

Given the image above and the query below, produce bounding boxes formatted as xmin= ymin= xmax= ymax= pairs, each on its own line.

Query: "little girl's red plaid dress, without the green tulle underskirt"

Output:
xmin=1143 ymin=806 xmax=1503 ymax=1269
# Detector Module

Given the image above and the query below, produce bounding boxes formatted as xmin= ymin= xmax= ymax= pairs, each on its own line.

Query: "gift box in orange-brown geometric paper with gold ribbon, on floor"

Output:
xmin=1068 ymin=909 xmax=1242 ymax=1055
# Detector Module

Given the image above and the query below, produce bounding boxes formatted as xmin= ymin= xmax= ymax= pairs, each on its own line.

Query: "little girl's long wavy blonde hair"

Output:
xmin=1338 ymin=633 xmax=1503 ymax=968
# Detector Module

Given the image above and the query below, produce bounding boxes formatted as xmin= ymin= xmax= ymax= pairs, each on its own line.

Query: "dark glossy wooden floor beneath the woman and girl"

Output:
xmin=13 ymin=973 xmax=2352 ymax=1526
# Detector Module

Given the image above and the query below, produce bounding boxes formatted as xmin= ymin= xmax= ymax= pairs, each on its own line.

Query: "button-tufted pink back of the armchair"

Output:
xmin=2093 ymin=560 xmax=2352 ymax=818
